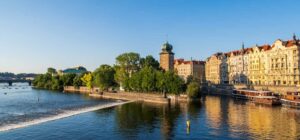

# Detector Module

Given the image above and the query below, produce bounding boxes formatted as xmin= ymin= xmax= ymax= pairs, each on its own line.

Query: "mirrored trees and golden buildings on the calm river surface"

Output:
xmin=110 ymin=96 xmax=300 ymax=139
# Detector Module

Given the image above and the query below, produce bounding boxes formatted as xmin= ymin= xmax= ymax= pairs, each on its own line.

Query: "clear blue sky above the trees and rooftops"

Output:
xmin=0 ymin=0 xmax=300 ymax=73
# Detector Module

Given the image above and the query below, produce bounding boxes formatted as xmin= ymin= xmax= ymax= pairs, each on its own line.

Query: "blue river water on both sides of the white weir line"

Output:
xmin=0 ymin=85 xmax=300 ymax=140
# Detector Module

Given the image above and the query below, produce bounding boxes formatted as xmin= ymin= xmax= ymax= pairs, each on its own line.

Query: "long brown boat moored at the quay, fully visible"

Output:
xmin=232 ymin=89 xmax=281 ymax=105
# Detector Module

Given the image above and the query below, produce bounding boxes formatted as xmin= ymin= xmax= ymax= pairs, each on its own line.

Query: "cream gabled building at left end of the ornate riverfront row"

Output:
xmin=205 ymin=53 xmax=228 ymax=84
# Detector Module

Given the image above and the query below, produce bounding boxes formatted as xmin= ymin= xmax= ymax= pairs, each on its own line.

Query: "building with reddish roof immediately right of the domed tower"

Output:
xmin=174 ymin=59 xmax=205 ymax=82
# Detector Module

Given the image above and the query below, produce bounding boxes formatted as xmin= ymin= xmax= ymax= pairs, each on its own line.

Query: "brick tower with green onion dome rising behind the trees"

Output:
xmin=159 ymin=42 xmax=174 ymax=71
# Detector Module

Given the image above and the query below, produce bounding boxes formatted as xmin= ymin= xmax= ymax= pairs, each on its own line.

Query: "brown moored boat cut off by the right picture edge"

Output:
xmin=280 ymin=91 xmax=300 ymax=108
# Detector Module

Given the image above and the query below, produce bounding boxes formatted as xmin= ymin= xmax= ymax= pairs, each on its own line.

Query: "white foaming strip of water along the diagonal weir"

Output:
xmin=0 ymin=101 xmax=131 ymax=132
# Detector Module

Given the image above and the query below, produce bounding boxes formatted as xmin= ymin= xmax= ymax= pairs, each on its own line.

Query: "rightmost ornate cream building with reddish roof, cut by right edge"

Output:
xmin=264 ymin=35 xmax=300 ymax=85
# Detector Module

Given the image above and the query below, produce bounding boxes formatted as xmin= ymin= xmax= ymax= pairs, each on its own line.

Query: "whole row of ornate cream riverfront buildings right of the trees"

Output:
xmin=205 ymin=35 xmax=300 ymax=85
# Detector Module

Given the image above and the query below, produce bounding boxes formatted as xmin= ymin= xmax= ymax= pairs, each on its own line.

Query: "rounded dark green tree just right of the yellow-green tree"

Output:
xmin=93 ymin=65 xmax=115 ymax=90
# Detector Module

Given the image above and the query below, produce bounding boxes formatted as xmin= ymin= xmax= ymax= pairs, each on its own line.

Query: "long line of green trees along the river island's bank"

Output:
xmin=33 ymin=52 xmax=199 ymax=97
